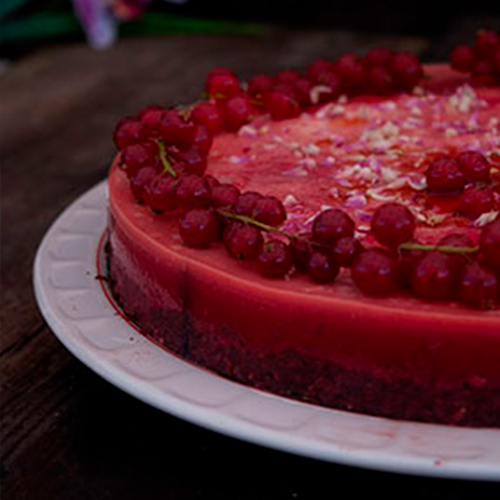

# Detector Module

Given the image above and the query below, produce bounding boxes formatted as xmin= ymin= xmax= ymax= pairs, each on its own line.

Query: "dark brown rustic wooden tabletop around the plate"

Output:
xmin=0 ymin=30 xmax=500 ymax=500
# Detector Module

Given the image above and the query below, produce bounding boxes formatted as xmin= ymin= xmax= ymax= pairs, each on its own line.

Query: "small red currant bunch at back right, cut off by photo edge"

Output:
xmin=450 ymin=30 xmax=500 ymax=85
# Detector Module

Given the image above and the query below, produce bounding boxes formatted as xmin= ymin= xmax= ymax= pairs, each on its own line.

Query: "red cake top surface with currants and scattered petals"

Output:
xmin=114 ymin=32 xmax=500 ymax=309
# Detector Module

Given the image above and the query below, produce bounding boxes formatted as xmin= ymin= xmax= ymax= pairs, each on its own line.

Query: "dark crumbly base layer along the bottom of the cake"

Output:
xmin=108 ymin=247 xmax=500 ymax=427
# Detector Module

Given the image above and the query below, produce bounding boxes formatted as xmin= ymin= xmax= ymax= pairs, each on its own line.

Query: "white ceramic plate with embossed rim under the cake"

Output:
xmin=34 ymin=183 xmax=500 ymax=480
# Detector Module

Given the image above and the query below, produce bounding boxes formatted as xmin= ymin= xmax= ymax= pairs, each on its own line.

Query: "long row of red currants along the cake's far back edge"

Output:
xmin=198 ymin=48 xmax=423 ymax=126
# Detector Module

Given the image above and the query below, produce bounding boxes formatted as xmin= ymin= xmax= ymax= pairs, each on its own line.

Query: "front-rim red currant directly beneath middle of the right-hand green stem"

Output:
xmin=411 ymin=252 xmax=456 ymax=300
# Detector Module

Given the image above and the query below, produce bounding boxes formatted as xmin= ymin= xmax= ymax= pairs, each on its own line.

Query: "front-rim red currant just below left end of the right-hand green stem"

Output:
xmin=351 ymin=248 xmax=398 ymax=296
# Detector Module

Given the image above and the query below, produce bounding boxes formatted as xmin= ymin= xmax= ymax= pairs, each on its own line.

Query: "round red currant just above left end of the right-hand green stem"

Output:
xmin=371 ymin=203 xmax=415 ymax=249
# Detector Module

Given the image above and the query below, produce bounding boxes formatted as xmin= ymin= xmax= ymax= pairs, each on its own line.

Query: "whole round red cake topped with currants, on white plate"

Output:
xmin=107 ymin=36 xmax=500 ymax=427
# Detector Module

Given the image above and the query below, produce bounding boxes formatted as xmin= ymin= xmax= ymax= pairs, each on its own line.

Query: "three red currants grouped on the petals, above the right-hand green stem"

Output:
xmin=425 ymin=151 xmax=495 ymax=219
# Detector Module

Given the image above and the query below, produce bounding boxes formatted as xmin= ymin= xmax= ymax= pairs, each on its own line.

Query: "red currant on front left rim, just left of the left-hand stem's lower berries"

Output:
xmin=179 ymin=208 xmax=219 ymax=248
